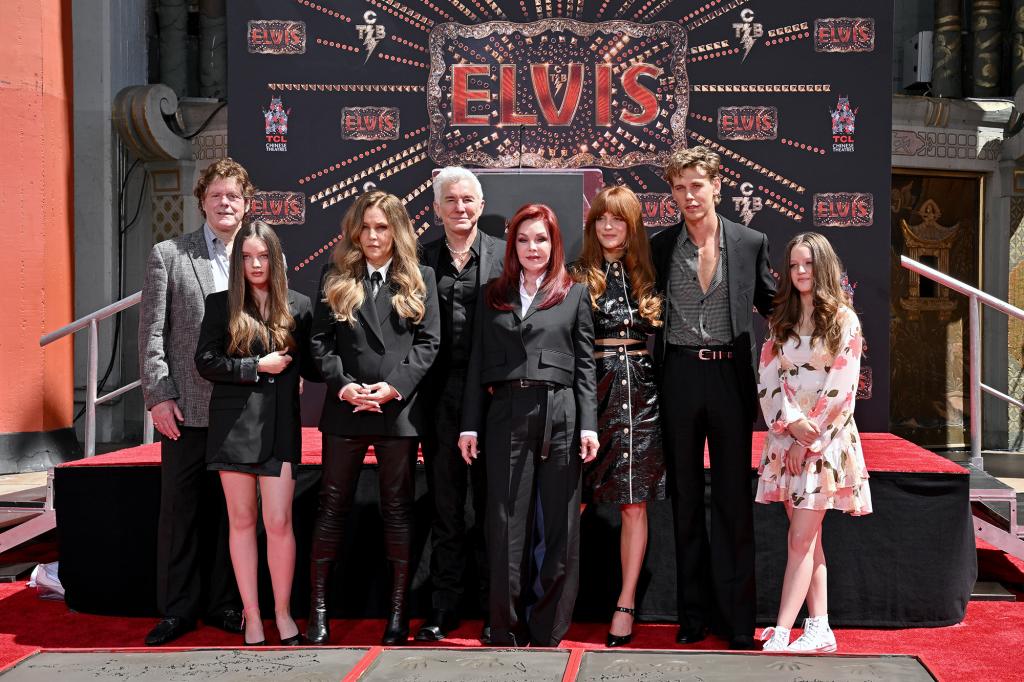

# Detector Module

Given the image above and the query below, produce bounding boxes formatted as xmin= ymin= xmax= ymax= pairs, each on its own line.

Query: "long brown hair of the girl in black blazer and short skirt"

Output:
xmin=227 ymin=220 xmax=295 ymax=356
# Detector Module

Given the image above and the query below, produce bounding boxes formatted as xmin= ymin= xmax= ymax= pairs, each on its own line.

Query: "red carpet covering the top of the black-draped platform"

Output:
xmin=61 ymin=427 xmax=967 ymax=473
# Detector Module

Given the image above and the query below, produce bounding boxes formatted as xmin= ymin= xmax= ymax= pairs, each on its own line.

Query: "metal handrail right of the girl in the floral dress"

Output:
xmin=899 ymin=256 xmax=1024 ymax=470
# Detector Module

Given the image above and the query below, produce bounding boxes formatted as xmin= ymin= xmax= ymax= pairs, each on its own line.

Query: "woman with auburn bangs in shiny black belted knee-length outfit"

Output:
xmin=573 ymin=186 xmax=665 ymax=646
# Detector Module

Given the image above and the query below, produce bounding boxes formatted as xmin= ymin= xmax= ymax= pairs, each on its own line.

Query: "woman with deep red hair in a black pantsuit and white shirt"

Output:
xmin=459 ymin=204 xmax=598 ymax=646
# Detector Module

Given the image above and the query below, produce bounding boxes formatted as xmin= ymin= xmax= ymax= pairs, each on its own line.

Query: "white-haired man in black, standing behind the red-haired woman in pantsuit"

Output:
xmin=416 ymin=167 xmax=505 ymax=642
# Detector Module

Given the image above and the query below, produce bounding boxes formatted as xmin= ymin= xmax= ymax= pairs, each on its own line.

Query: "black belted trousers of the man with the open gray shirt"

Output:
xmin=662 ymin=346 xmax=757 ymax=638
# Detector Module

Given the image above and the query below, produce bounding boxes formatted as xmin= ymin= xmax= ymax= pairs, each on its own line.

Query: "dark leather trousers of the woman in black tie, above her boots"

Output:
xmin=312 ymin=433 xmax=416 ymax=564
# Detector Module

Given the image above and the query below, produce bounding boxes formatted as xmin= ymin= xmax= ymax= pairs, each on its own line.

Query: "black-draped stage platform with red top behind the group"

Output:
xmin=54 ymin=430 xmax=977 ymax=628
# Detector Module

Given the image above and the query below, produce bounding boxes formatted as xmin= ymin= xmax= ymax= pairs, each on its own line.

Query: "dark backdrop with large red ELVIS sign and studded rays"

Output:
xmin=228 ymin=0 xmax=892 ymax=431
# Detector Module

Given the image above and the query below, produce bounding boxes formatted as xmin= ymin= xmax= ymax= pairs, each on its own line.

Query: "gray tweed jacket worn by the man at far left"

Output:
xmin=138 ymin=229 xmax=220 ymax=427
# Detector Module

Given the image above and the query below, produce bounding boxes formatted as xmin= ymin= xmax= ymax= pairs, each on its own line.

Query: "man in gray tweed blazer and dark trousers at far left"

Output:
xmin=138 ymin=159 xmax=255 ymax=646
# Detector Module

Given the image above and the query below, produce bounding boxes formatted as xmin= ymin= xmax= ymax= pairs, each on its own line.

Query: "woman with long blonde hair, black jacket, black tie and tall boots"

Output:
xmin=306 ymin=190 xmax=440 ymax=645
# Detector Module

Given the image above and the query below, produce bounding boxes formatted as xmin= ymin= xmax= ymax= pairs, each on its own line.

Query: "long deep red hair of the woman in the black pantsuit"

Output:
xmin=484 ymin=204 xmax=572 ymax=310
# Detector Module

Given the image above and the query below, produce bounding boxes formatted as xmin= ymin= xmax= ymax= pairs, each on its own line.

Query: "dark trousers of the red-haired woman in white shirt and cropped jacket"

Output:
xmin=483 ymin=387 xmax=582 ymax=646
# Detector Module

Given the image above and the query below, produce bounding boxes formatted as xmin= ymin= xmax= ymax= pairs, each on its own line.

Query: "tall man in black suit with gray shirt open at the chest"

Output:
xmin=651 ymin=146 xmax=775 ymax=649
